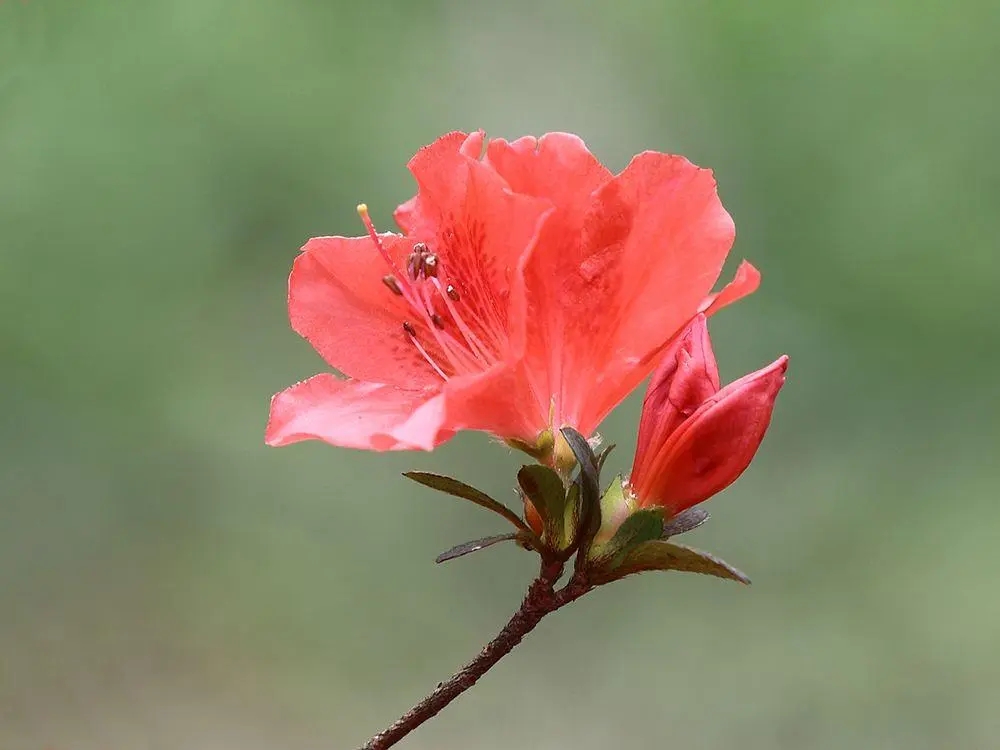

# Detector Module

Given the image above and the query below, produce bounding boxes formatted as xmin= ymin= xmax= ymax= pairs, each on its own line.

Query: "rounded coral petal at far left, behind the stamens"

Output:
xmin=288 ymin=234 xmax=441 ymax=388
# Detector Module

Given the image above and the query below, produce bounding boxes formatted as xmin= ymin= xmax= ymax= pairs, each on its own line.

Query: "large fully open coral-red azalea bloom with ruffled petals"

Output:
xmin=267 ymin=132 xmax=759 ymax=450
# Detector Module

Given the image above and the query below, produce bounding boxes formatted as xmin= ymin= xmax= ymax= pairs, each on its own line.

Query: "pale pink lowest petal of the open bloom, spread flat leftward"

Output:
xmin=265 ymin=373 xmax=454 ymax=451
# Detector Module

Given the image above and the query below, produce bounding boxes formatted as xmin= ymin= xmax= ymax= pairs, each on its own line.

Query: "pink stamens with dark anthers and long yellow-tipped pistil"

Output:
xmin=358 ymin=203 xmax=504 ymax=380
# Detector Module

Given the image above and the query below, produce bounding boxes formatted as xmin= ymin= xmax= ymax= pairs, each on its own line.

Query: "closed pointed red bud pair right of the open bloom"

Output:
xmin=626 ymin=315 xmax=788 ymax=517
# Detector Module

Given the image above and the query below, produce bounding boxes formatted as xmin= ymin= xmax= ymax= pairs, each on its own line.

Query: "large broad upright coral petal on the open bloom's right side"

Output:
xmin=525 ymin=152 xmax=734 ymax=434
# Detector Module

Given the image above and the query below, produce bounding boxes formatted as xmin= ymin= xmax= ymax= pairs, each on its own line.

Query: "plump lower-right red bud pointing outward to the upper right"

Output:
xmin=636 ymin=356 xmax=788 ymax=515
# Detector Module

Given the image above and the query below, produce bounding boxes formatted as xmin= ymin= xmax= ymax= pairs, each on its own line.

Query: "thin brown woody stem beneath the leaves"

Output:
xmin=360 ymin=562 xmax=591 ymax=750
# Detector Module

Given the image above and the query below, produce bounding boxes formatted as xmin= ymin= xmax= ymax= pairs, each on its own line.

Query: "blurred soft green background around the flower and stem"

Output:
xmin=0 ymin=0 xmax=1000 ymax=750
